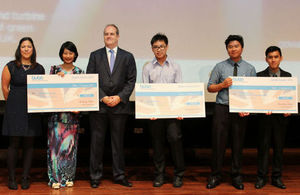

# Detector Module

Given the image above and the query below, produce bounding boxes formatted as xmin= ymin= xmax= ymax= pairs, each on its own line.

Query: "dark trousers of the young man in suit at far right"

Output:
xmin=257 ymin=114 xmax=288 ymax=179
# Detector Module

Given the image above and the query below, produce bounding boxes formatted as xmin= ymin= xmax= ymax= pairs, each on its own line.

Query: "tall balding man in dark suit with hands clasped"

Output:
xmin=86 ymin=24 xmax=136 ymax=188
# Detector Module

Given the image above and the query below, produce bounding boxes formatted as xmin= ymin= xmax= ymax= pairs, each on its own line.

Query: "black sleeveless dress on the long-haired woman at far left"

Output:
xmin=2 ymin=61 xmax=45 ymax=136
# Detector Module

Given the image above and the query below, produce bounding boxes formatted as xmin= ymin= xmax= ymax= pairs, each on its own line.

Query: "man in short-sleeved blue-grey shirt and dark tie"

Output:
xmin=206 ymin=35 xmax=256 ymax=190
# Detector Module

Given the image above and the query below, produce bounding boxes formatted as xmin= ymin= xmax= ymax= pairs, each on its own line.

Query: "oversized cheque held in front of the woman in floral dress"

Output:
xmin=27 ymin=74 xmax=99 ymax=113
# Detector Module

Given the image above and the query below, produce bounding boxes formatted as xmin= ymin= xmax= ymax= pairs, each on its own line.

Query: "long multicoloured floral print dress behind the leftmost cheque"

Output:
xmin=47 ymin=65 xmax=83 ymax=187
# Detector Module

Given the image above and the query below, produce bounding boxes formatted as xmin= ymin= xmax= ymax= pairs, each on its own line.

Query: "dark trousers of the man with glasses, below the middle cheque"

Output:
xmin=149 ymin=119 xmax=184 ymax=177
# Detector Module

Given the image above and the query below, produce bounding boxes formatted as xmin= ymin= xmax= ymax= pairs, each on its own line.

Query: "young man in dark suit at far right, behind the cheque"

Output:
xmin=255 ymin=46 xmax=292 ymax=189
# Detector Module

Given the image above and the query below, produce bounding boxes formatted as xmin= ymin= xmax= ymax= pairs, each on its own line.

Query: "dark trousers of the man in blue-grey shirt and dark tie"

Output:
xmin=211 ymin=104 xmax=247 ymax=179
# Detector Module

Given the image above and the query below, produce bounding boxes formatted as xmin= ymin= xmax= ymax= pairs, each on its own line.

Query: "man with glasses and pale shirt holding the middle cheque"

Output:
xmin=143 ymin=33 xmax=184 ymax=187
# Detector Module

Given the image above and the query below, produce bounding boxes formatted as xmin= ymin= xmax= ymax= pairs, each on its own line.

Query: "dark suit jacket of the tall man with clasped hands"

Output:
xmin=86 ymin=47 xmax=136 ymax=114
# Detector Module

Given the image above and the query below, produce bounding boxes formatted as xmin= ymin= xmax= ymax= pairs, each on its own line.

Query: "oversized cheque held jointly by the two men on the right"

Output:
xmin=229 ymin=77 xmax=298 ymax=113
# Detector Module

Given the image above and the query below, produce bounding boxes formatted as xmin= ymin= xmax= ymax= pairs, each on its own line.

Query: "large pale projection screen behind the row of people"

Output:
xmin=0 ymin=0 xmax=300 ymax=102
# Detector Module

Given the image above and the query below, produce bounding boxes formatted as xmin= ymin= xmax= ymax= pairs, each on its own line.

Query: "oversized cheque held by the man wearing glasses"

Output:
xmin=135 ymin=83 xmax=205 ymax=119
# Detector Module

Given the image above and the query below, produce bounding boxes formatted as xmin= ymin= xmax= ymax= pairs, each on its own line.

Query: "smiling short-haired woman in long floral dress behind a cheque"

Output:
xmin=47 ymin=41 xmax=83 ymax=189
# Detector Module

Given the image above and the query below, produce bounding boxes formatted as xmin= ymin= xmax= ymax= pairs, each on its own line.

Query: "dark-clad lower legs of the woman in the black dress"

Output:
xmin=7 ymin=136 xmax=34 ymax=178
